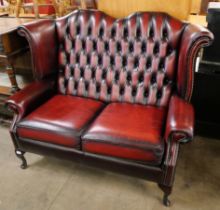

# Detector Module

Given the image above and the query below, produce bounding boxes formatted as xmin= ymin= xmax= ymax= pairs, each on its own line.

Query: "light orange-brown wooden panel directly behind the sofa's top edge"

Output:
xmin=97 ymin=0 xmax=191 ymax=20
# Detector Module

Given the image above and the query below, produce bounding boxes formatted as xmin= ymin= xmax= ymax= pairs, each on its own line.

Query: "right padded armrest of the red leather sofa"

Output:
xmin=165 ymin=96 xmax=194 ymax=142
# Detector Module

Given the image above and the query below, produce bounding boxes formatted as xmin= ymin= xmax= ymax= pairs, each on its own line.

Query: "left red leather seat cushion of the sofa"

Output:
xmin=17 ymin=95 xmax=104 ymax=148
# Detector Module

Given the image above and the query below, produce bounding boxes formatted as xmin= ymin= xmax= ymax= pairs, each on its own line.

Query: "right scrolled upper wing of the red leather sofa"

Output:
xmin=177 ymin=24 xmax=214 ymax=101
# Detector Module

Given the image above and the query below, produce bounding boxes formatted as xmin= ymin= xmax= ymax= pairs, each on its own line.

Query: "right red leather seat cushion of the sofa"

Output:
xmin=82 ymin=103 xmax=166 ymax=165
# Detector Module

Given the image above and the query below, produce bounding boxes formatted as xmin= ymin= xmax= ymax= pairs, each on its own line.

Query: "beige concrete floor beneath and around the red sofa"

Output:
xmin=0 ymin=124 xmax=220 ymax=210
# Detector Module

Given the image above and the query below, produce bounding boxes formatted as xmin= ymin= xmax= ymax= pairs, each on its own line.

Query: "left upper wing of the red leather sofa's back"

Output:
xmin=18 ymin=20 xmax=58 ymax=80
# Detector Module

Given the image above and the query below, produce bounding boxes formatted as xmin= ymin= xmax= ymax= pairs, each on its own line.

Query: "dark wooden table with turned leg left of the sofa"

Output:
xmin=0 ymin=18 xmax=32 ymax=121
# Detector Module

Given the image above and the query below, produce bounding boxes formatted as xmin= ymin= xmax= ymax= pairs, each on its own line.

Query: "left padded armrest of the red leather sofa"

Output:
xmin=6 ymin=80 xmax=54 ymax=121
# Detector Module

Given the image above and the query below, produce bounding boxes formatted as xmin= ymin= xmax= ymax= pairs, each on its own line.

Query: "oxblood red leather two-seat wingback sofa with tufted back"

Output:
xmin=7 ymin=10 xmax=213 ymax=205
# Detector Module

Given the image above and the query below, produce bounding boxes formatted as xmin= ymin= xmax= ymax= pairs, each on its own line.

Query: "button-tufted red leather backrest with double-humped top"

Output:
xmin=56 ymin=10 xmax=185 ymax=106
